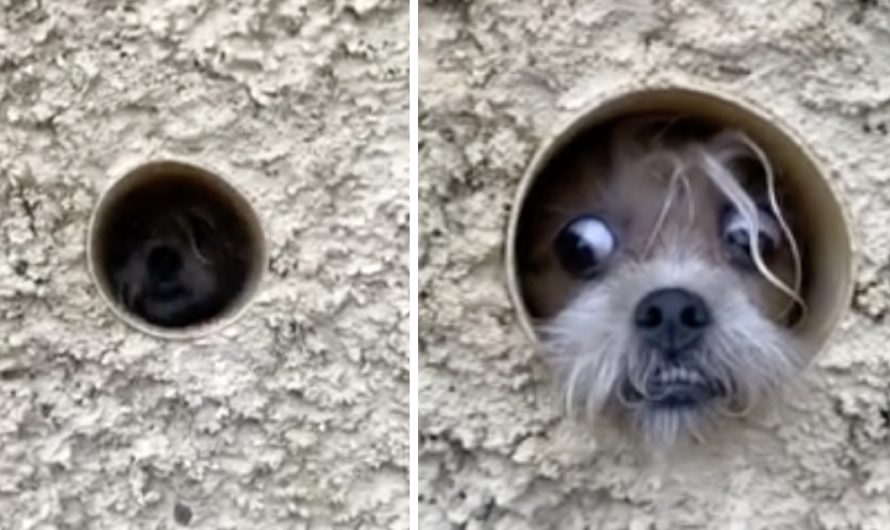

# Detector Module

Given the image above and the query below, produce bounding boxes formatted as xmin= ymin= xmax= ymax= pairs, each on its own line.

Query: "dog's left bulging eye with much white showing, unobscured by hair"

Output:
xmin=554 ymin=215 xmax=616 ymax=278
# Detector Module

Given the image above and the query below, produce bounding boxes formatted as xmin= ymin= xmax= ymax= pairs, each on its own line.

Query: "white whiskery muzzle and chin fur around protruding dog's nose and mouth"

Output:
xmin=541 ymin=253 xmax=803 ymax=449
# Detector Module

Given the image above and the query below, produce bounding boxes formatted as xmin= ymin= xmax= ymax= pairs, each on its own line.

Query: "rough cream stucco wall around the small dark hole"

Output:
xmin=0 ymin=0 xmax=408 ymax=530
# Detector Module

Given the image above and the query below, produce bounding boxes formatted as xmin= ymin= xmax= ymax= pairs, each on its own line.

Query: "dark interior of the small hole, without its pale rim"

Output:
xmin=97 ymin=173 xmax=259 ymax=328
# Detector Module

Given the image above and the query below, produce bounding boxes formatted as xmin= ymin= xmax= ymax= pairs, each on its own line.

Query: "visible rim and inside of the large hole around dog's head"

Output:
xmin=506 ymin=86 xmax=853 ymax=354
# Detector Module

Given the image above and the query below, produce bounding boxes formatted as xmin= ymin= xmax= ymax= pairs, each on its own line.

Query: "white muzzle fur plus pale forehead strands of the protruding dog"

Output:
xmin=540 ymin=127 xmax=803 ymax=447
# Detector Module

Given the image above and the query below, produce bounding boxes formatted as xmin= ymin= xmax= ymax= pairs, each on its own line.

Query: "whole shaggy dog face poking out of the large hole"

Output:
xmin=518 ymin=118 xmax=802 ymax=445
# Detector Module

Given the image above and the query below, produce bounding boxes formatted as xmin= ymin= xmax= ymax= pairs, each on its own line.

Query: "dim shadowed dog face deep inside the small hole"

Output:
xmin=107 ymin=194 xmax=245 ymax=327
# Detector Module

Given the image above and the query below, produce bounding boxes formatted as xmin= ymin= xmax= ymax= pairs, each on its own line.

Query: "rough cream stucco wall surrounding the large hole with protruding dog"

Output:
xmin=420 ymin=0 xmax=890 ymax=530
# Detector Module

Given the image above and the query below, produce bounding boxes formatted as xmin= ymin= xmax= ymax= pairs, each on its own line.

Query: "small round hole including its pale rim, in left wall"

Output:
xmin=88 ymin=160 xmax=266 ymax=338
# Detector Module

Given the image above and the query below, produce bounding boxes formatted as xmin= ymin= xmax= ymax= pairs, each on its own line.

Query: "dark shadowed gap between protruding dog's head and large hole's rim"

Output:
xmin=514 ymin=112 xmax=813 ymax=327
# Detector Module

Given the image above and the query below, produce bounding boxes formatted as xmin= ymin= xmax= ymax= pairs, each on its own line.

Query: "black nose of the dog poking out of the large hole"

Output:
xmin=634 ymin=288 xmax=711 ymax=353
